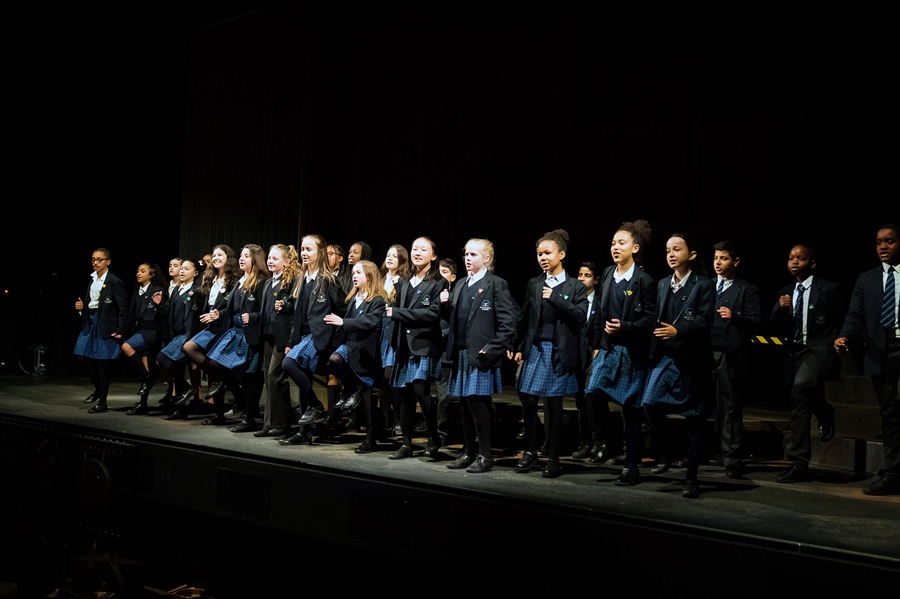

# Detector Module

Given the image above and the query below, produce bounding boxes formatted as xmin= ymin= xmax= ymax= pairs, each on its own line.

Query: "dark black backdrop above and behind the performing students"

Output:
xmin=0 ymin=2 xmax=900 ymax=376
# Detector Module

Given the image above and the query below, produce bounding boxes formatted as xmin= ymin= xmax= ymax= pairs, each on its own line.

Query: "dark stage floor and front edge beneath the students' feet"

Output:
xmin=0 ymin=375 xmax=900 ymax=597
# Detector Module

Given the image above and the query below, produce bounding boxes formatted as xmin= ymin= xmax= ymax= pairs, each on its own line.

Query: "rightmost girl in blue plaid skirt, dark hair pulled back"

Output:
xmin=636 ymin=233 xmax=715 ymax=499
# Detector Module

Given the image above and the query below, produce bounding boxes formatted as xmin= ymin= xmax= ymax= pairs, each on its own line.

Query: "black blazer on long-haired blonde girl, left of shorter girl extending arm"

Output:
xmin=282 ymin=275 xmax=347 ymax=352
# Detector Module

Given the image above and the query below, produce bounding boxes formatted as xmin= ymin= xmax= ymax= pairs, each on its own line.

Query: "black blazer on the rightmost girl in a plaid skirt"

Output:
xmin=650 ymin=272 xmax=716 ymax=376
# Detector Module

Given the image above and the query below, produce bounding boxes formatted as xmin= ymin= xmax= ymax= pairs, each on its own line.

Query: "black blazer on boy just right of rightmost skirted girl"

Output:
xmin=710 ymin=277 xmax=762 ymax=377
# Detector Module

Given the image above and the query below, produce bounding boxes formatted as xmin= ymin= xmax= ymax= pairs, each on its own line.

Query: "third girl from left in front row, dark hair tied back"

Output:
xmin=156 ymin=258 xmax=206 ymax=420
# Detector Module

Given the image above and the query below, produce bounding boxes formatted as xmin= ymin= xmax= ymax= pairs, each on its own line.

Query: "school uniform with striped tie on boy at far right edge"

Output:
xmin=838 ymin=263 xmax=900 ymax=494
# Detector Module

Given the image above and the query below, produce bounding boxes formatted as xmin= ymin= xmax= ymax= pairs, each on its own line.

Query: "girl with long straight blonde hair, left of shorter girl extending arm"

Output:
xmin=280 ymin=235 xmax=346 ymax=445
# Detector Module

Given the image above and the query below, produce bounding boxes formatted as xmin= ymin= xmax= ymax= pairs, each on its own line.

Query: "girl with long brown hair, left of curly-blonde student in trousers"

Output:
xmin=201 ymin=243 xmax=269 ymax=426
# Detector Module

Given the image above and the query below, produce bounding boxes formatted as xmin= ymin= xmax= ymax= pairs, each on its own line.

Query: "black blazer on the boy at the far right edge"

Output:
xmin=840 ymin=265 xmax=897 ymax=375
